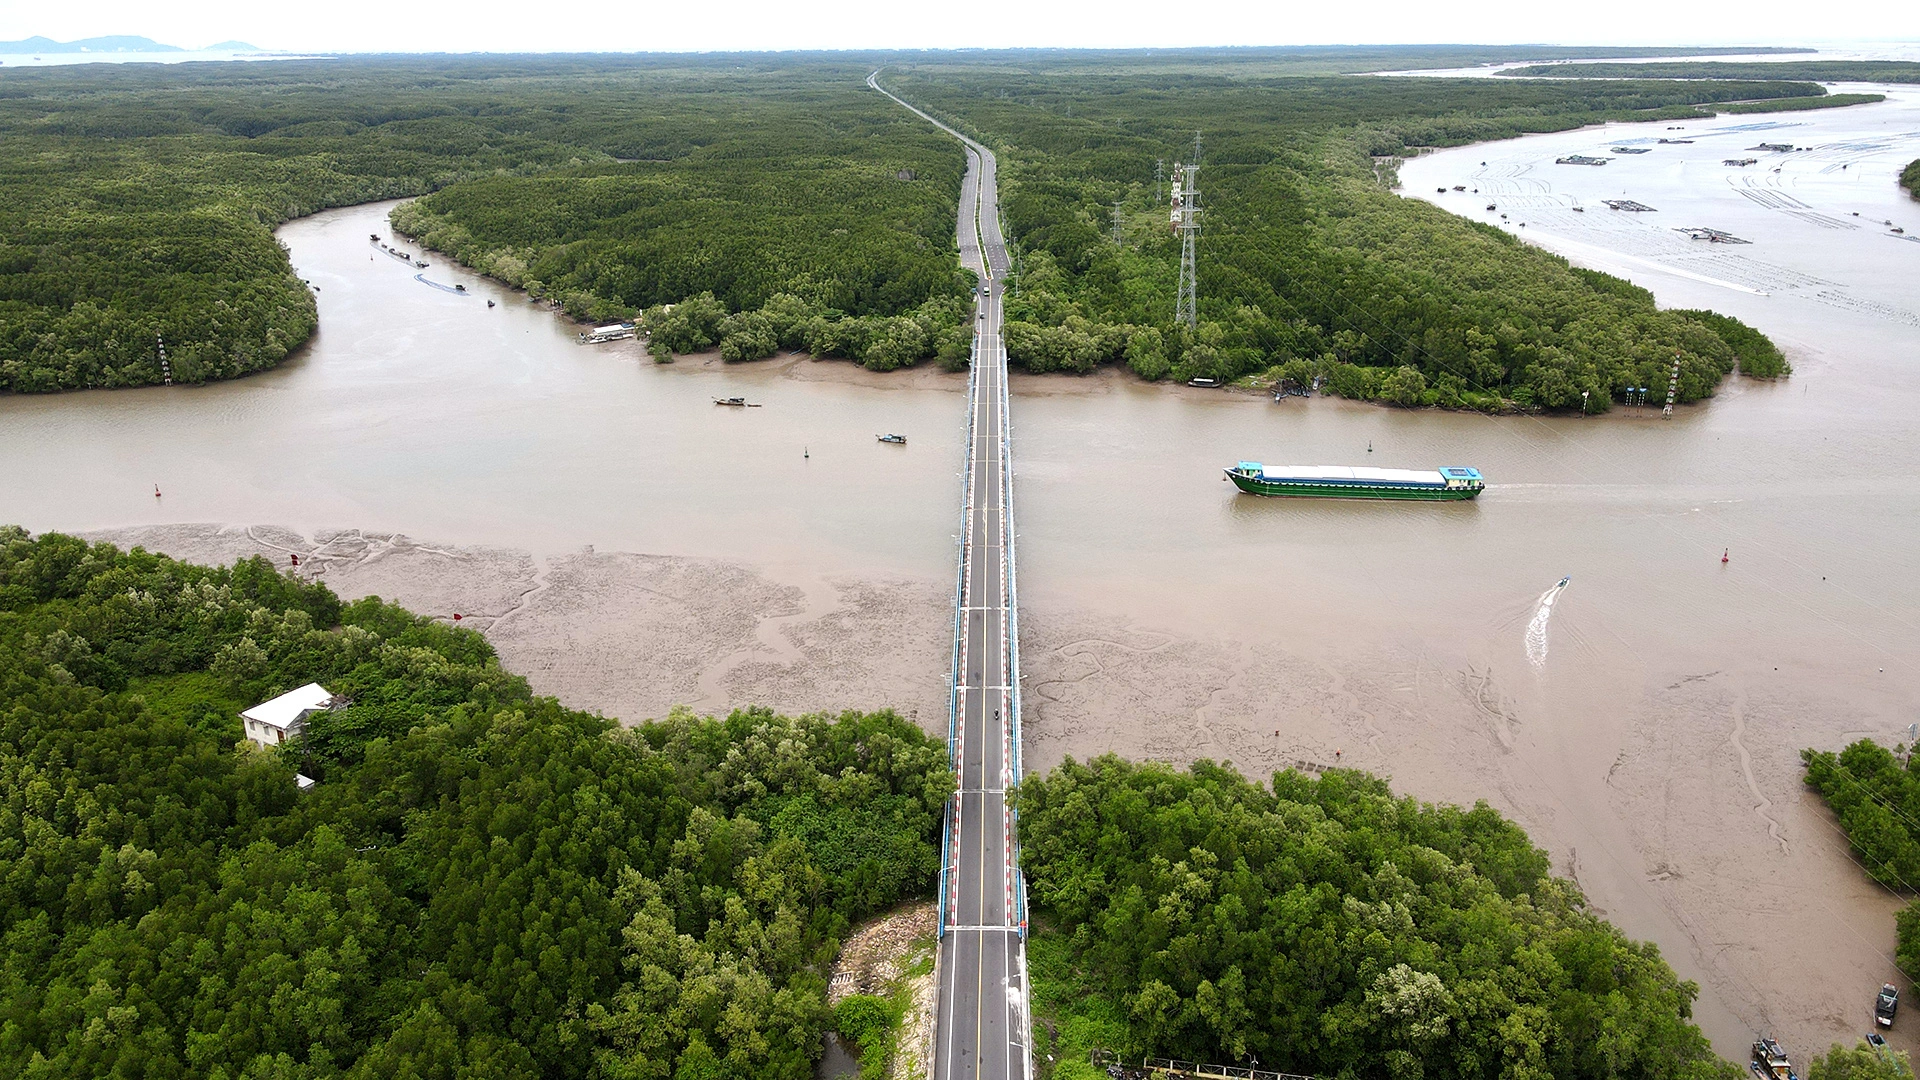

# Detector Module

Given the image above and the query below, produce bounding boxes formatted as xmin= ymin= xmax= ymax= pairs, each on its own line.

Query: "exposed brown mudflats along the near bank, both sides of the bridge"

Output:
xmin=84 ymin=507 xmax=1912 ymax=1057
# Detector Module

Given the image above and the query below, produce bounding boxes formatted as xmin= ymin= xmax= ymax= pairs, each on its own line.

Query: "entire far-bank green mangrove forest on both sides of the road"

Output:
xmin=0 ymin=46 xmax=1820 ymax=395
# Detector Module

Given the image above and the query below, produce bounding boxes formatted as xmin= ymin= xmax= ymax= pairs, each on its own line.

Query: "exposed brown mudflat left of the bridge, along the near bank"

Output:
xmin=88 ymin=525 xmax=952 ymax=732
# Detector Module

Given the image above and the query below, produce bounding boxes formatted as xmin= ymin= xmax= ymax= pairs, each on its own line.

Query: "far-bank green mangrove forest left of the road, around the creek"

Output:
xmin=0 ymin=56 xmax=962 ymax=392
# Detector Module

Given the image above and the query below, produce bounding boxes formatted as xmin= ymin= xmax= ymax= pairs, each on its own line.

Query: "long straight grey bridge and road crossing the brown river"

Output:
xmin=866 ymin=71 xmax=1033 ymax=1080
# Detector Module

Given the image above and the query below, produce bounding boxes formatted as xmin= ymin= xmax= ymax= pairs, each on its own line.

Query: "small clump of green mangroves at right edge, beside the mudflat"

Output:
xmin=1801 ymin=738 xmax=1920 ymax=978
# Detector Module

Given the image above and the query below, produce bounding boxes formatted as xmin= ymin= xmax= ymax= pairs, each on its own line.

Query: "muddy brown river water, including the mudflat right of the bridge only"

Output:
xmin=0 ymin=90 xmax=1920 ymax=1059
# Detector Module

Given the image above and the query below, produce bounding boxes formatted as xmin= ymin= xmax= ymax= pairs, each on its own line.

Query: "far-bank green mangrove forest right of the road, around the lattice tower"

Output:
xmin=895 ymin=65 xmax=1797 ymax=403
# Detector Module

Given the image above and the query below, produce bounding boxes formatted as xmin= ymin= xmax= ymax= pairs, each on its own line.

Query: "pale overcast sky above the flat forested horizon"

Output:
xmin=0 ymin=0 xmax=1920 ymax=52
